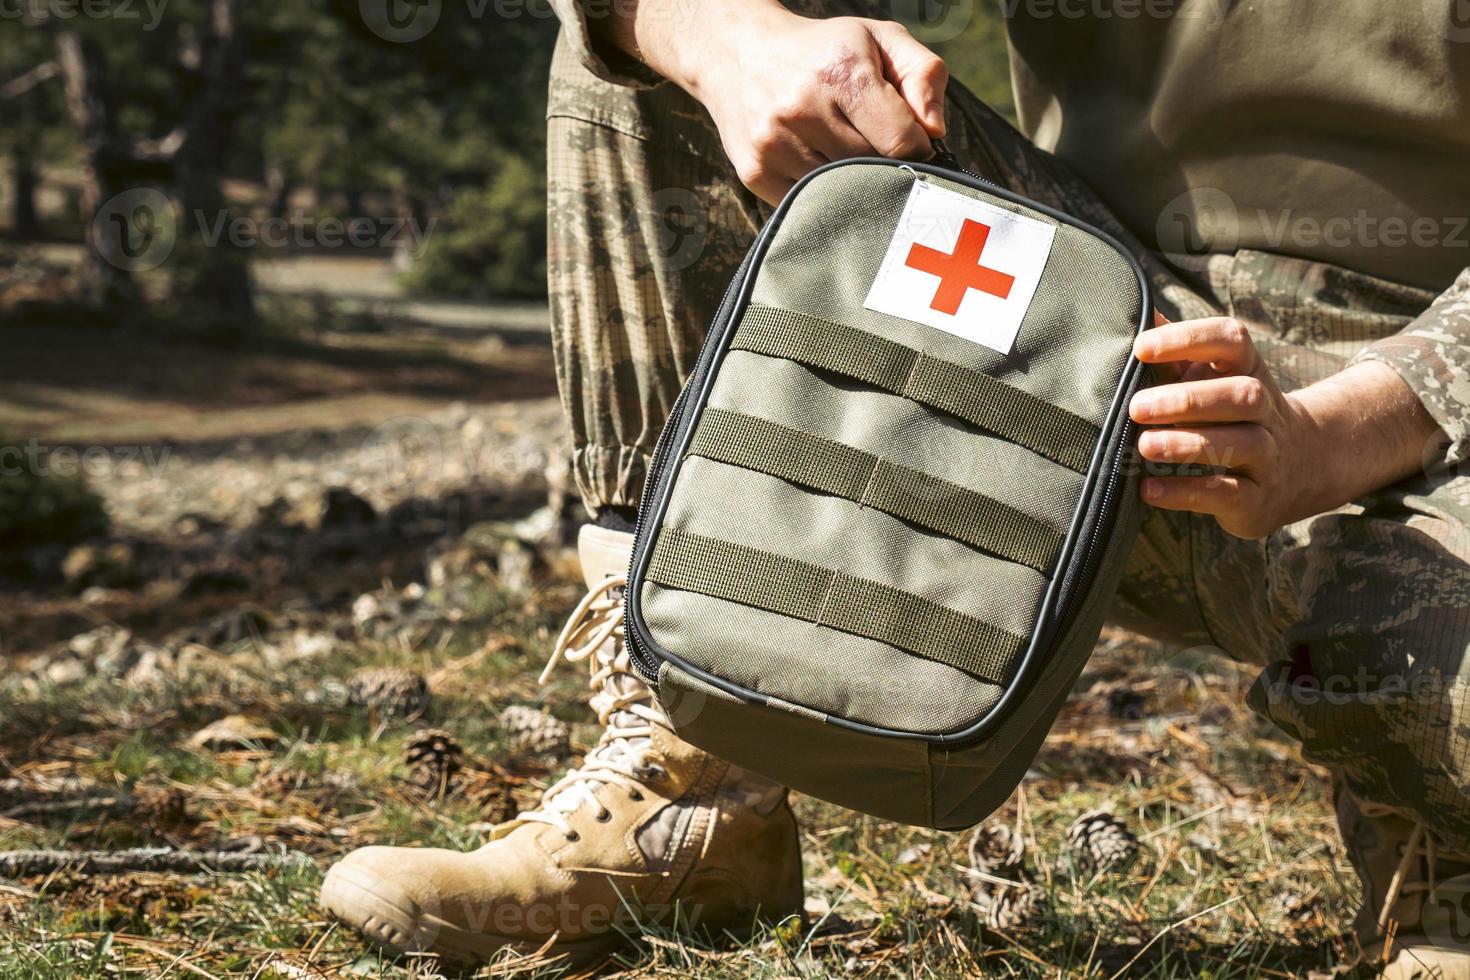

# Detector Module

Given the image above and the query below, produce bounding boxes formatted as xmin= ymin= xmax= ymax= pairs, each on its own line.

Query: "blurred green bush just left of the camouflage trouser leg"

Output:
xmin=404 ymin=156 xmax=547 ymax=298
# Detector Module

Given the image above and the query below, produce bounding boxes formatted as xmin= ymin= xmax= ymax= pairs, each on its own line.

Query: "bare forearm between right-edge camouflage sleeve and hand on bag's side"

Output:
xmin=1288 ymin=361 xmax=1446 ymax=516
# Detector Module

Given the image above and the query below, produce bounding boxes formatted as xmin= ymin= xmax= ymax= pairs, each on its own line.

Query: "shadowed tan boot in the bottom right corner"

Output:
xmin=1335 ymin=780 xmax=1470 ymax=980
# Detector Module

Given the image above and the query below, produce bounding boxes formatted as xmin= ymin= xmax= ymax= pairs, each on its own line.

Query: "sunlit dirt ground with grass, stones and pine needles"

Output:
xmin=0 ymin=257 xmax=1358 ymax=977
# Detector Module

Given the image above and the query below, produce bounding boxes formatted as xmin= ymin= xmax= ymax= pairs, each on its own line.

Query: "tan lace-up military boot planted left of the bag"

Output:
xmin=320 ymin=527 xmax=803 ymax=964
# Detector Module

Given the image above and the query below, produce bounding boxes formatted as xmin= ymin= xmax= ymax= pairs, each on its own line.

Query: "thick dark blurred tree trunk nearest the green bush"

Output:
xmin=173 ymin=0 xmax=259 ymax=329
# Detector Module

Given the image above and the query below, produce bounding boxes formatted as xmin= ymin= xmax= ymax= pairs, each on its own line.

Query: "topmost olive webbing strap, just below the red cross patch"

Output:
xmin=731 ymin=304 xmax=1101 ymax=473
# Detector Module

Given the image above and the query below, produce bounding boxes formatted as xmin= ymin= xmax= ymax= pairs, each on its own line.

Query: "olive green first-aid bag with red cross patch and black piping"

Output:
xmin=625 ymin=159 xmax=1152 ymax=829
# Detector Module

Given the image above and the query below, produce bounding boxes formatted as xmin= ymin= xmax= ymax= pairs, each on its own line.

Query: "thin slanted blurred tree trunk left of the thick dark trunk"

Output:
xmin=56 ymin=31 xmax=140 ymax=307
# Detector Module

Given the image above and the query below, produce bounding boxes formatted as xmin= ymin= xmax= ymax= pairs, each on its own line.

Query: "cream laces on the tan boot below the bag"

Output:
xmin=517 ymin=576 xmax=669 ymax=840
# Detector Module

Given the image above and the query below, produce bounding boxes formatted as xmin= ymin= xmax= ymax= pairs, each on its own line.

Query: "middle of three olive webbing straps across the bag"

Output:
xmin=689 ymin=408 xmax=1061 ymax=573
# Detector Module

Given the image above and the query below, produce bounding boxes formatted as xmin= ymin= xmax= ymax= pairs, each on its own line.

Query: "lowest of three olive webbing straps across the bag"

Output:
xmin=647 ymin=527 xmax=1026 ymax=685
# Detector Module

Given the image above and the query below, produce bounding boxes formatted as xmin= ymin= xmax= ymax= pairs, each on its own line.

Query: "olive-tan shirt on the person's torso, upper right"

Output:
xmin=1001 ymin=0 xmax=1470 ymax=289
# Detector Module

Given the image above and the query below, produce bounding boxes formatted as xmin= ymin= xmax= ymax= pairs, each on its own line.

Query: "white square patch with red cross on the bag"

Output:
xmin=863 ymin=181 xmax=1057 ymax=354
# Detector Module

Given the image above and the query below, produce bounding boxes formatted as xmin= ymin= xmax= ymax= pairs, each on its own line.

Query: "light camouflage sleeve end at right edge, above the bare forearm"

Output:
xmin=1352 ymin=269 xmax=1470 ymax=466
